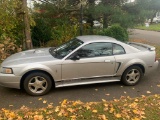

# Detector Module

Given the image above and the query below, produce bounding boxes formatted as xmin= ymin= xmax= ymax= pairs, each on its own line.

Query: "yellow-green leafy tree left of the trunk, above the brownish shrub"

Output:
xmin=0 ymin=0 xmax=23 ymax=44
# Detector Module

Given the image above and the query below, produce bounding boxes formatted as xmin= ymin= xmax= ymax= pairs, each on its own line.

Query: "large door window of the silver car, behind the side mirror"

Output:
xmin=77 ymin=43 xmax=112 ymax=58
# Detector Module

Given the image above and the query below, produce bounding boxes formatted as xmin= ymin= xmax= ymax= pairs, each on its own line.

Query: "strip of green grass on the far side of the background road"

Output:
xmin=136 ymin=23 xmax=160 ymax=31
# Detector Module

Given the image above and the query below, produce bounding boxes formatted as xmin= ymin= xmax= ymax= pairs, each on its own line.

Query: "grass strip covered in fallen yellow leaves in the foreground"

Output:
xmin=0 ymin=95 xmax=160 ymax=120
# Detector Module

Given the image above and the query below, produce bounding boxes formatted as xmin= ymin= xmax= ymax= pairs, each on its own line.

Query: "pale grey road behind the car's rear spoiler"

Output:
xmin=130 ymin=29 xmax=160 ymax=45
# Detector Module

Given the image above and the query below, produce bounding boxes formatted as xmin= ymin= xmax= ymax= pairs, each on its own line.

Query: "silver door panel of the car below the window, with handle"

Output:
xmin=62 ymin=56 xmax=115 ymax=80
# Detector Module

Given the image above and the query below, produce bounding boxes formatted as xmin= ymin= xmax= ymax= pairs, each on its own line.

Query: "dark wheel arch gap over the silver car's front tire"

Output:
xmin=20 ymin=69 xmax=55 ymax=89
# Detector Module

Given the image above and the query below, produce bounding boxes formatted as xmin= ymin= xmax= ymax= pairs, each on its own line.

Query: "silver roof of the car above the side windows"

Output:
xmin=77 ymin=35 xmax=117 ymax=43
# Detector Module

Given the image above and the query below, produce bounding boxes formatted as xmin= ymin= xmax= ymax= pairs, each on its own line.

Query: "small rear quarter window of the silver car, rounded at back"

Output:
xmin=113 ymin=44 xmax=126 ymax=55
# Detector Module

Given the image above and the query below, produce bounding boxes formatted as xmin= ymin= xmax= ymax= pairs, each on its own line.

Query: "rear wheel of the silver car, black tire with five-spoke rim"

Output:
xmin=121 ymin=66 xmax=143 ymax=86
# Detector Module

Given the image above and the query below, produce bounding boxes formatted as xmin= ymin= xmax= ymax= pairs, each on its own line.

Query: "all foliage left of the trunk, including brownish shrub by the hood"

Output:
xmin=0 ymin=0 xmax=23 ymax=60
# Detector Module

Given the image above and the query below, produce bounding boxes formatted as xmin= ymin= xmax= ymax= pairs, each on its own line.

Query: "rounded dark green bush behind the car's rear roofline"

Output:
xmin=99 ymin=25 xmax=128 ymax=42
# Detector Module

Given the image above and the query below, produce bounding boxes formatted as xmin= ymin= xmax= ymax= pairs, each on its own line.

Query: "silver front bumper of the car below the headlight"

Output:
xmin=0 ymin=73 xmax=21 ymax=89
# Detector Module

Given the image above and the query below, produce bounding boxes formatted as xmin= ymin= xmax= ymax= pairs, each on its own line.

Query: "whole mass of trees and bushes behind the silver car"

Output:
xmin=0 ymin=0 xmax=160 ymax=59
